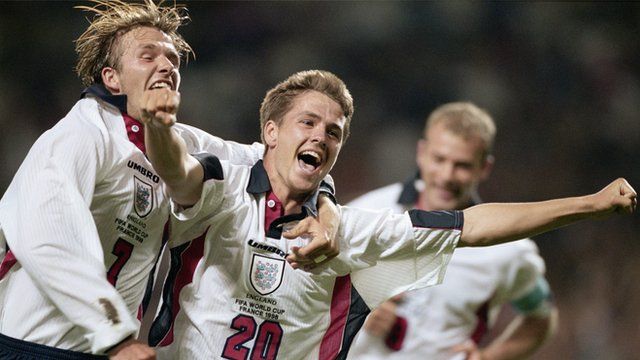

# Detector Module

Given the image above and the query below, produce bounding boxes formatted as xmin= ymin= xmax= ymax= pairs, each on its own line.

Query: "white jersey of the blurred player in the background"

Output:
xmin=349 ymin=182 xmax=549 ymax=360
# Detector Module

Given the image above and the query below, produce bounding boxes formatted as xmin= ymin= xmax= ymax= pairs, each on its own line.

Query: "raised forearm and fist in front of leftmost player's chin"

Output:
xmin=142 ymin=89 xmax=204 ymax=206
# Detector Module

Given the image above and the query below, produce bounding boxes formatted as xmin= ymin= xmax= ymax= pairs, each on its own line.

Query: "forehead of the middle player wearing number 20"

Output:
xmin=285 ymin=90 xmax=345 ymax=122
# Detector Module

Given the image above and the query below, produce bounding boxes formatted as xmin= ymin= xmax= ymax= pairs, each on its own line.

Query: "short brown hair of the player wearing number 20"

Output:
xmin=260 ymin=70 xmax=353 ymax=143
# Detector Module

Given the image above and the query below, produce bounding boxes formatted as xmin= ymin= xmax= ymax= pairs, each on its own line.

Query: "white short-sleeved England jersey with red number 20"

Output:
xmin=149 ymin=157 xmax=462 ymax=360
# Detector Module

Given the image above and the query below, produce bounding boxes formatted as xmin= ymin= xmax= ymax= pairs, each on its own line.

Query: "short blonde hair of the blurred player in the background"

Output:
xmin=424 ymin=102 xmax=496 ymax=158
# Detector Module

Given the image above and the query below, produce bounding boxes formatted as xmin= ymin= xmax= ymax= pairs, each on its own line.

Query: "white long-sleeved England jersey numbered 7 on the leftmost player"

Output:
xmin=0 ymin=86 xmax=262 ymax=353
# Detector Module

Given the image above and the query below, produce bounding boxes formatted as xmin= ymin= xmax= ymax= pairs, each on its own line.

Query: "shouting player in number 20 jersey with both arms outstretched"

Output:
xmin=140 ymin=70 xmax=636 ymax=359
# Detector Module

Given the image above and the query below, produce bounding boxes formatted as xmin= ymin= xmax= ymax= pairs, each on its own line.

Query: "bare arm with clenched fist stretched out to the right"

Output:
xmin=460 ymin=178 xmax=637 ymax=246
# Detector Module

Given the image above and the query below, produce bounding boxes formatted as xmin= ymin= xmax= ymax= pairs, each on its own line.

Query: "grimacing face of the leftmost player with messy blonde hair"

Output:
xmin=105 ymin=27 xmax=180 ymax=119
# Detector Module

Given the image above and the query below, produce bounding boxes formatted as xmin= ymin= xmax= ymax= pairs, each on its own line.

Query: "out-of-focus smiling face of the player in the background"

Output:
xmin=417 ymin=123 xmax=490 ymax=210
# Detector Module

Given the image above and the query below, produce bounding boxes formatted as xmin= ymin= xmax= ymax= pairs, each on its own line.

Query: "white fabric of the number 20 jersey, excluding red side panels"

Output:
xmin=159 ymin=162 xmax=460 ymax=359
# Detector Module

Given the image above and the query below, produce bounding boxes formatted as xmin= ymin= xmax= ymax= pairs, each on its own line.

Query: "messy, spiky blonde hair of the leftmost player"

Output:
xmin=75 ymin=0 xmax=194 ymax=86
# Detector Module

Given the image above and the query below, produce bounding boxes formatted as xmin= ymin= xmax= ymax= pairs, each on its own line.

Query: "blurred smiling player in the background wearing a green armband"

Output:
xmin=348 ymin=102 xmax=557 ymax=359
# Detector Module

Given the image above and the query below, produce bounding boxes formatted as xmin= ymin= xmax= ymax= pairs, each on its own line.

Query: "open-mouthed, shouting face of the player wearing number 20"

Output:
xmin=264 ymin=91 xmax=346 ymax=201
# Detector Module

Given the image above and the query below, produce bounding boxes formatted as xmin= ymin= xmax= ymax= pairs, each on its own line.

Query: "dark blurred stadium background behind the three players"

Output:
xmin=0 ymin=1 xmax=640 ymax=359
